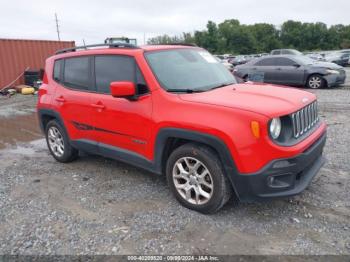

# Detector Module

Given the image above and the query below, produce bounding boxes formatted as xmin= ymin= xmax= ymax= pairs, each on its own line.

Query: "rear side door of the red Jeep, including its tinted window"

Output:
xmin=53 ymin=56 xmax=94 ymax=149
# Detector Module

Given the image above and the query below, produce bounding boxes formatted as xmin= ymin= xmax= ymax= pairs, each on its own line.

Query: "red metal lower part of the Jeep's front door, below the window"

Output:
xmin=92 ymin=94 xmax=152 ymax=156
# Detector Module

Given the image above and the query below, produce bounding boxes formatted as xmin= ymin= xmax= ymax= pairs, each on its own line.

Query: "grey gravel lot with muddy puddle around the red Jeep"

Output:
xmin=0 ymin=73 xmax=350 ymax=254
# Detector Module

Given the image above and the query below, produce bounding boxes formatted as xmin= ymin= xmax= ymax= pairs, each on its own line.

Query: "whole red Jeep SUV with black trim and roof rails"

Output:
xmin=37 ymin=44 xmax=326 ymax=213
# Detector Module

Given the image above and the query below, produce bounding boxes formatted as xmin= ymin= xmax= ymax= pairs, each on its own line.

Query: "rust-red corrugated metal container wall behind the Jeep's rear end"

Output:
xmin=0 ymin=39 xmax=75 ymax=89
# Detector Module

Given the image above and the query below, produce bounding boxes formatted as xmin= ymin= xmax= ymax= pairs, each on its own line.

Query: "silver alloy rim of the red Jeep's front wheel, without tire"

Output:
xmin=173 ymin=157 xmax=214 ymax=205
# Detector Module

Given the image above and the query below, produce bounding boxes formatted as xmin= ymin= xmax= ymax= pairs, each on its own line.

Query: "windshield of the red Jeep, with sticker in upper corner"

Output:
xmin=146 ymin=49 xmax=237 ymax=92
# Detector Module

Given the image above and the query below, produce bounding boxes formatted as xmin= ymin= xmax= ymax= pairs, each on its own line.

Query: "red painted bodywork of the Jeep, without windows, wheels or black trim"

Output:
xmin=38 ymin=46 xmax=326 ymax=174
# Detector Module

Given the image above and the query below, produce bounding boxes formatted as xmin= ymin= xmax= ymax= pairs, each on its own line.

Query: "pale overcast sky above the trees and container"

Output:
xmin=0 ymin=0 xmax=350 ymax=45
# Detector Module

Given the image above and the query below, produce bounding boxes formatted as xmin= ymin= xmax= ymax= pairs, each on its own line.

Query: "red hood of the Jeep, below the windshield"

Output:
xmin=179 ymin=82 xmax=316 ymax=117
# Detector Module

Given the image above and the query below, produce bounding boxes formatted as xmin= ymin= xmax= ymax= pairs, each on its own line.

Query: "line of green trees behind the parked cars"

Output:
xmin=148 ymin=19 xmax=350 ymax=54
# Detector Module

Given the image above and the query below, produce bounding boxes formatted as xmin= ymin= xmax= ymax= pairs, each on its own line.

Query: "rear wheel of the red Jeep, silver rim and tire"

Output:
xmin=45 ymin=120 xmax=79 ymax=163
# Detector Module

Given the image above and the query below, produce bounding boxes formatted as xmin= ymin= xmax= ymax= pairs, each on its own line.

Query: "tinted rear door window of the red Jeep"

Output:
xmin=64 ymin=56 xmax=90 ymax=90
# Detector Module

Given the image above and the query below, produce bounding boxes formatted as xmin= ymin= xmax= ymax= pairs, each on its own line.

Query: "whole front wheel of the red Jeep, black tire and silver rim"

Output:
xmin=166 ymin=143 xmax=232 ymax=214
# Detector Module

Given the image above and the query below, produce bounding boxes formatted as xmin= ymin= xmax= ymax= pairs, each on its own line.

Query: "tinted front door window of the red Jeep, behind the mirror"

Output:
xmin=95 ymin=55 xmax=148 ymax=94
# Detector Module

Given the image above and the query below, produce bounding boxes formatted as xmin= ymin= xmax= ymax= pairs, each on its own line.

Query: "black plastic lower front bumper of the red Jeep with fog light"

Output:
xmin=231 ymin=133 xmax=326 ymax=202
